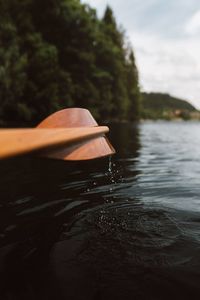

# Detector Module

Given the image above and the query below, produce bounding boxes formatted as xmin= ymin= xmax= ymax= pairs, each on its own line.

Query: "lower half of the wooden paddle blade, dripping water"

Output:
xmin=39 ymin=136 xmax=115 ymax=161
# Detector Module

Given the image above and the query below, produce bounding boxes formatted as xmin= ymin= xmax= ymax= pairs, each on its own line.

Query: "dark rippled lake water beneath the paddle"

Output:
xmin=0 ymin=122 xmax=200 ymax=300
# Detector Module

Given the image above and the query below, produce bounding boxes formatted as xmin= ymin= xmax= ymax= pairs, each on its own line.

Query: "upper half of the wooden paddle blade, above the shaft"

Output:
xmin=37 ymin=108 xmax=98 ymax=128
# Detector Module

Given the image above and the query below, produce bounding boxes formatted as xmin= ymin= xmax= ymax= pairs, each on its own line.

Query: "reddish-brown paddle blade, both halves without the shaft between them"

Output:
xmin=37 ymin=108 xmax=115 ymax=160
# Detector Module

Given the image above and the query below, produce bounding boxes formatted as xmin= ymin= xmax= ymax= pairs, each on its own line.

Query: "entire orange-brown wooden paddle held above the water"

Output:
xmin=0 ymin=108 xmax=115 ymax=160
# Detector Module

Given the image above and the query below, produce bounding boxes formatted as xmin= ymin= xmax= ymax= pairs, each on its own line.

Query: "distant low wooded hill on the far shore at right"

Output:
xmin=141 ymin=93 xmax=198 ymax=120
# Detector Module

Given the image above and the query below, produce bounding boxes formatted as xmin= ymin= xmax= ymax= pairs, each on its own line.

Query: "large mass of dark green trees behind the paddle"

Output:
xmin=0 ymin=0 xmax=140 ymax=126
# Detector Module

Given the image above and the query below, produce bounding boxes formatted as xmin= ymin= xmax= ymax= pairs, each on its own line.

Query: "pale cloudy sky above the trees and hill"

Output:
xmin=82 ymin=0 xmax=200 ymax=109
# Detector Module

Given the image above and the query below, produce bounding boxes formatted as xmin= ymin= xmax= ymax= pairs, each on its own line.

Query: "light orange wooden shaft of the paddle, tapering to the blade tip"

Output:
xmin=0 ymin=126 xmax=109 ymax=159
